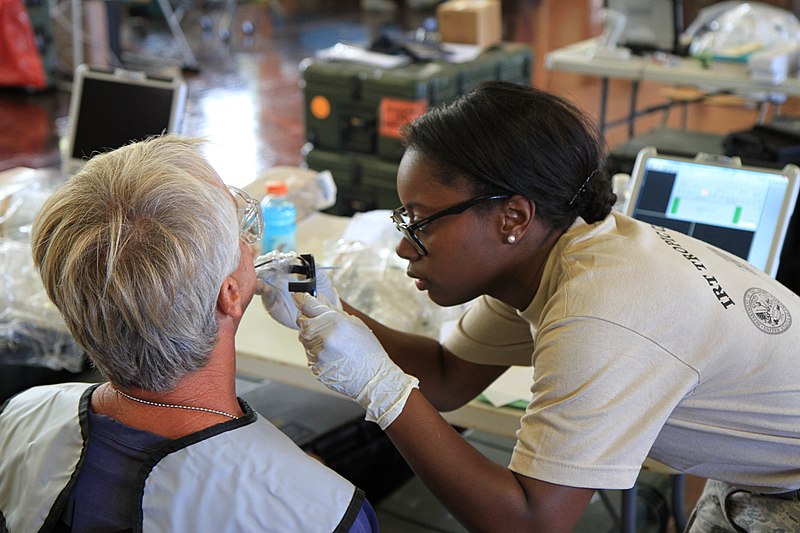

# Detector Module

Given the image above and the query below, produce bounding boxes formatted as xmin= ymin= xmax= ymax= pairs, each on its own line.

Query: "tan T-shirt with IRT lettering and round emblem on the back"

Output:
xmin=445 ymin=213 xmax=800 ymax=492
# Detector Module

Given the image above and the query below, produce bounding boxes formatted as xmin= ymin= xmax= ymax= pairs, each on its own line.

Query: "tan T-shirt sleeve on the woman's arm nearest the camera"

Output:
xmin=509 ymin=317 xmax=697 ymax=489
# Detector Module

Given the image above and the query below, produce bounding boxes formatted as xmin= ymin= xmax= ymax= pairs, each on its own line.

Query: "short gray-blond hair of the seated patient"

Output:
xmin=31 ymin=135 xmax=239 ymax=392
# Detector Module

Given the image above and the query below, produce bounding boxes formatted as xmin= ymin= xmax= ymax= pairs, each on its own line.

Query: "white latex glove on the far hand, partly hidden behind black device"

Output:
xmin=255 ymin=250 xmax=341 ymax=329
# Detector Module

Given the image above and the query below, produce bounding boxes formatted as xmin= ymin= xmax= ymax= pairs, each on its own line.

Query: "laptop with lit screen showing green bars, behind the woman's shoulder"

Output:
xmin=627 ymin=147 xmax=800 ymax=277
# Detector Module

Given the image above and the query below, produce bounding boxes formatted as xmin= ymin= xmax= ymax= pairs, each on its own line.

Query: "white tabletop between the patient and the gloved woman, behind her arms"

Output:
xmin=236 ymin=213 xmax=523 ymax=438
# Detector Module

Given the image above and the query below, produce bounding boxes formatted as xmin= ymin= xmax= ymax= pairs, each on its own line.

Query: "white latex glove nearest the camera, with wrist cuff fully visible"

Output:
xmin=294 ymin=294 xmax=419 ymax=429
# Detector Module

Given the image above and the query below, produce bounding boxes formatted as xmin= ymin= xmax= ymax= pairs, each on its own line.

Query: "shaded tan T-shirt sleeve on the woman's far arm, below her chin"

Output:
xmin=444 ymin=296 xmax=533 ymax=366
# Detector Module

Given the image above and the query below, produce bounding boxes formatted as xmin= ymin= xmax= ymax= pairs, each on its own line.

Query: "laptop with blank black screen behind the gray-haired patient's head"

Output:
xmin=62 ymin=65 xmax=187 ymax=177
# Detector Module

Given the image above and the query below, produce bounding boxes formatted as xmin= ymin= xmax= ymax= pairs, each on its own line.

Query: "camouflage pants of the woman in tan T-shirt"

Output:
xmin=686 ymin=480 xmax=800 ymax=533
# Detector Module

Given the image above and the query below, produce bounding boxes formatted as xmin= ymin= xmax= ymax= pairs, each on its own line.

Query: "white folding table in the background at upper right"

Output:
xmin=545 ymin=38 xmax=800 ymax=136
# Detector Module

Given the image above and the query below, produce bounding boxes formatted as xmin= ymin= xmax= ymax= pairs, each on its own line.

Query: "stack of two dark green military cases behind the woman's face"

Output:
xmin=300 ymin=43 xmax=533 ymax=215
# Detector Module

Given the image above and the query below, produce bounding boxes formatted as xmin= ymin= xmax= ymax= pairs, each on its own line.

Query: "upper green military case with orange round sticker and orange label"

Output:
xmin=300 ymin=43 xmax=533 ymax=160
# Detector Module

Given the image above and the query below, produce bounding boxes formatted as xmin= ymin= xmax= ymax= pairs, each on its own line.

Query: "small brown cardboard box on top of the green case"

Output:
xmin=436 ymin=0 xmax=503 ymax=48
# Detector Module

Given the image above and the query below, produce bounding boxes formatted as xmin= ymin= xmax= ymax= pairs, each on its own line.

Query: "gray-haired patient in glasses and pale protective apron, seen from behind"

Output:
xmin=0 ymin=135 xmax=377 ymax=532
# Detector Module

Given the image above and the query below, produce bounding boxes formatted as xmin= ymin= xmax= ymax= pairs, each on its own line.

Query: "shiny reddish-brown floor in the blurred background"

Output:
xmin=0 ymin=0 xmax=780 ymax=524
